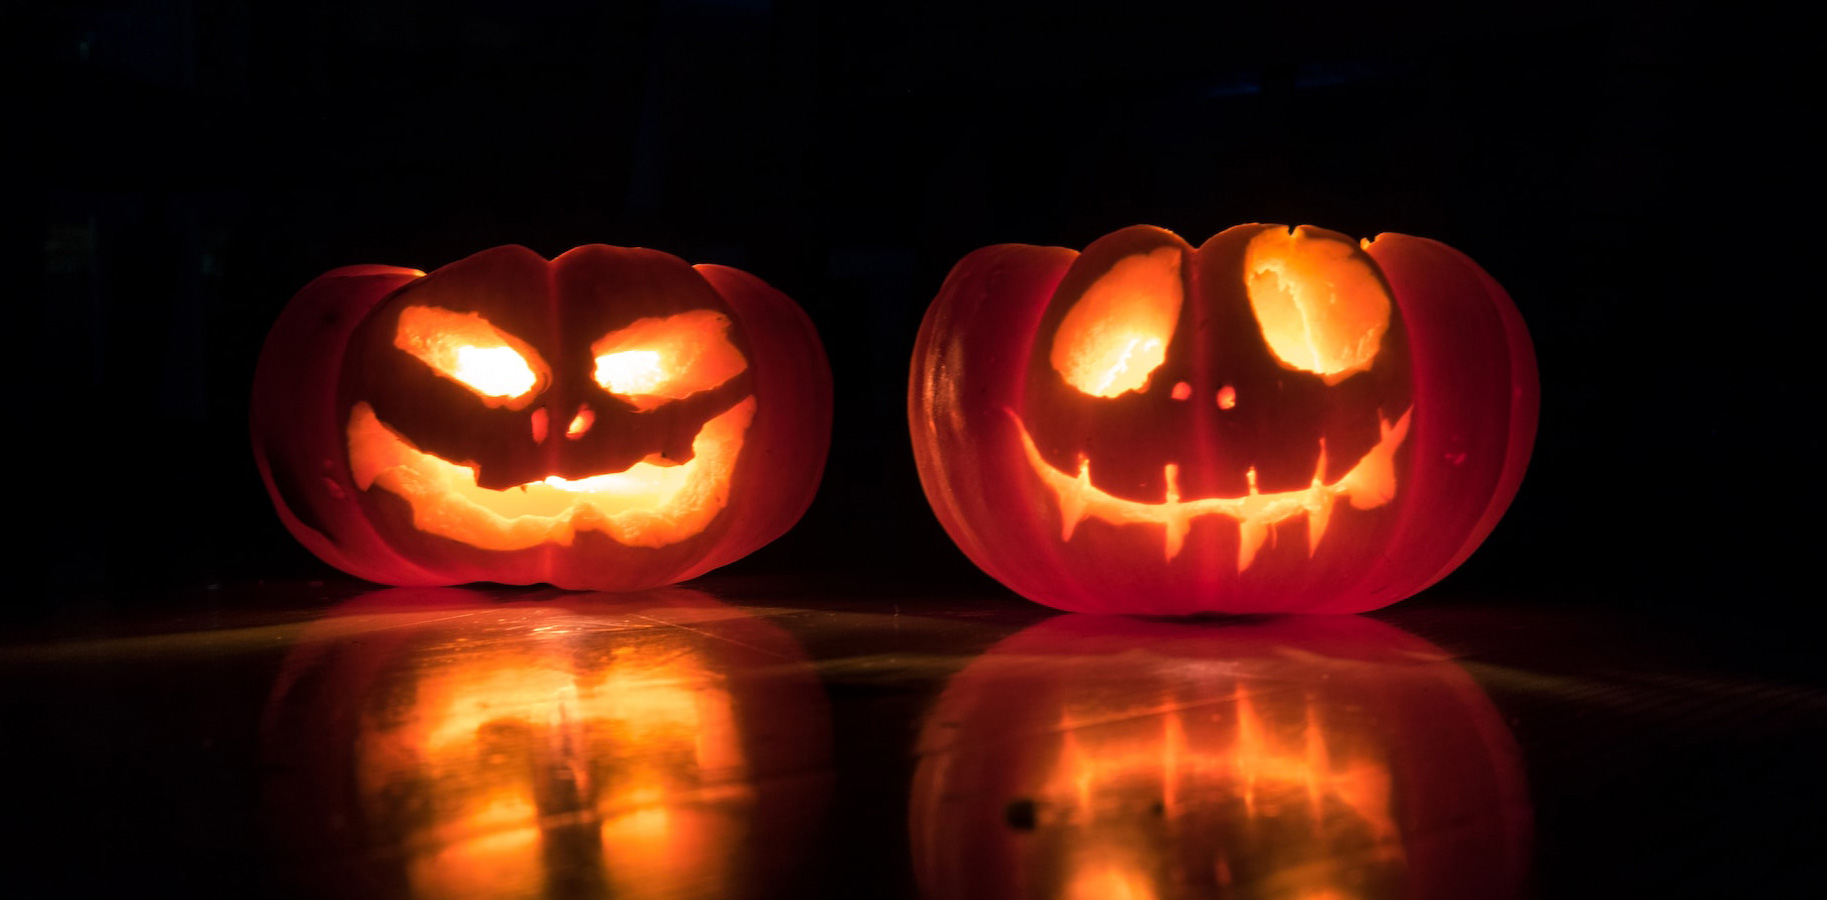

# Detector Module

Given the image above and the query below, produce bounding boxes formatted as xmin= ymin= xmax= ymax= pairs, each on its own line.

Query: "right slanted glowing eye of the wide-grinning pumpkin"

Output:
xmin=590 ymin=309 xmax=749 ymax=411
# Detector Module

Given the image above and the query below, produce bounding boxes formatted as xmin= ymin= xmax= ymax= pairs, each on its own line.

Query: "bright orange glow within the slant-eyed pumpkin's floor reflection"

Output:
xmin=358 ymin=630 xmax=753 ymax=900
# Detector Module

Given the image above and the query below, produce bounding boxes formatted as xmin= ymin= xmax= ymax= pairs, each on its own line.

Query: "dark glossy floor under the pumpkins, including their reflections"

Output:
xmin=0 ymin=577 xmax=1827 ymax=900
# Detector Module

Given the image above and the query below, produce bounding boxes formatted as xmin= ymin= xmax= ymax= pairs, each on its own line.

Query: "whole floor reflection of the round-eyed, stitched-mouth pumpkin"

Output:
xmin=910 ymin=615 xmax=1529 ymax=900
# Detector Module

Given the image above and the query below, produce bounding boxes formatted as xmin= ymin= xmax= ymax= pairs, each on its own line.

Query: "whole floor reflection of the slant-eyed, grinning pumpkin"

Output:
xmin=267 ymin=590 xmax=829 ymax=900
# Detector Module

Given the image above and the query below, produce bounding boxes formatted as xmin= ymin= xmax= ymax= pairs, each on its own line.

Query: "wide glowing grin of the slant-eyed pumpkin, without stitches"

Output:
xmin=349 ymin=396 xmax=755 ymax=549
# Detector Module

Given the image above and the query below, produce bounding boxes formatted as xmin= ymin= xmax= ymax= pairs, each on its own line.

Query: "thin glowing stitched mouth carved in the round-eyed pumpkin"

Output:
xmin=1005 ymin=407 xmax=1414 ymax=571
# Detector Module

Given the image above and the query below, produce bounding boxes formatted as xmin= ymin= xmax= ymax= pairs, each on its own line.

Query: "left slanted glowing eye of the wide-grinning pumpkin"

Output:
xmin=393 ymin=307 xmax=544 ymax=409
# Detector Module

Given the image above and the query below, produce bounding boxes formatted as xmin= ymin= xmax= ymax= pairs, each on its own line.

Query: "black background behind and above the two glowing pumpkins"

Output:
xmin=5 ymin=0 xmax=1822 ymax=617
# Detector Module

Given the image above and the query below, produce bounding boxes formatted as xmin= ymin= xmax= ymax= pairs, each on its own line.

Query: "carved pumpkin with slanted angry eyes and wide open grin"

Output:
xmin=252 ymin=245 xmax=831 ymax=590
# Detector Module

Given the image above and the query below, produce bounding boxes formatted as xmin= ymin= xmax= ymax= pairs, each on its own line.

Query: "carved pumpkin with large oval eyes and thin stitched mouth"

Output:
xmin=908 ymin=225 xmax=1538 ymax=615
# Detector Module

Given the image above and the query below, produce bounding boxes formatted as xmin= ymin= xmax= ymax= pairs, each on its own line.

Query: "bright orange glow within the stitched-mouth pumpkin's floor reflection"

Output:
xmin=1034 ymin=685 xmax=1407 ymax=900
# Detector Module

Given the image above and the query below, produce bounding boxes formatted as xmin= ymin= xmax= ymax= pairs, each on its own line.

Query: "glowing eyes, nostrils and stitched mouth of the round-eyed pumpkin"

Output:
xmin=1009 ymin=230 xmax=1409 ymax=571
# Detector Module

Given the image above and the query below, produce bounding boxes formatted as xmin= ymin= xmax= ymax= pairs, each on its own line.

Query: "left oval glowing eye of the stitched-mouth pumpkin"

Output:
xmin=1049 ymin=246 xmax=1186 ymax=396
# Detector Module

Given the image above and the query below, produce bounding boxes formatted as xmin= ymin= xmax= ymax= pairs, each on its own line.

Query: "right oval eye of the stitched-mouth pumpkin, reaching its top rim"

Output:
xmin=1244 ymin=228 xmax=1390 ymax=385
